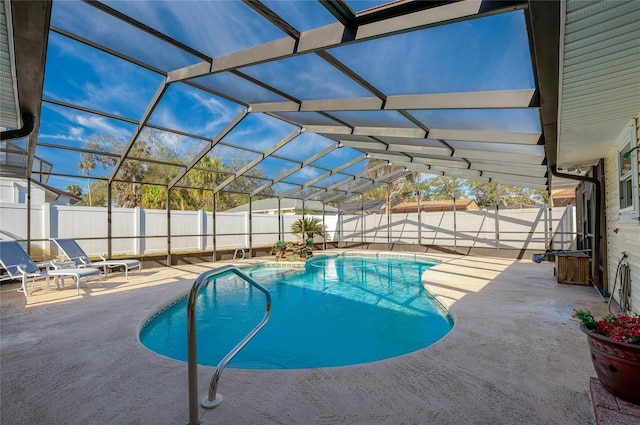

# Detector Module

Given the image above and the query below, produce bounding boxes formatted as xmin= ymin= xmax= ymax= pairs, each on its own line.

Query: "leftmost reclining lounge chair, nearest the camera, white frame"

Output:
xmin=0 ymin=240 xmax=102 ymax=297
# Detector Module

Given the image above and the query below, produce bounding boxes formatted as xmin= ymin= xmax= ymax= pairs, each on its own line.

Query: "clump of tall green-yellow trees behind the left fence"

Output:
xmin=78 ymin=130 xmax=263 ymax=211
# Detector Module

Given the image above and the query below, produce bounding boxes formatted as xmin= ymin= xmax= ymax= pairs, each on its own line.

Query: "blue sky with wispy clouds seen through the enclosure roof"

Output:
xmin=36 ymin=0 xmax=540 ymax=194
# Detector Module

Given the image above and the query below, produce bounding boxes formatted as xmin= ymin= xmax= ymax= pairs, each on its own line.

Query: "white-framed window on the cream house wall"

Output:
xmin=616 ymin=120 xmax=640 ymax=223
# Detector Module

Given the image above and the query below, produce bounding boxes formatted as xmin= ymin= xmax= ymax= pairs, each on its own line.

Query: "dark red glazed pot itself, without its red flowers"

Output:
xmin=580 ymin=326 xmax=640 ymax=404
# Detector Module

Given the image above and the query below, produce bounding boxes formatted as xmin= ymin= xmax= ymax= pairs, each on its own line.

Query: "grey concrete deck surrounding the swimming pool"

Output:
xmin=0 ymin=251 xmax=620 ymax=425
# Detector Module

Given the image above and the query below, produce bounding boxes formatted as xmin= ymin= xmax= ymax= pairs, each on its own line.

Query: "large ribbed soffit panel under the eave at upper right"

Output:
xmin=558 ymin=0 xmax=640 ymax=169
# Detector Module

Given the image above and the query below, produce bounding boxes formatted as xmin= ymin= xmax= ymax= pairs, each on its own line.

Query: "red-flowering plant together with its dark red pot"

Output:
xmin=573 ymin=310 xmax=640 ymax=404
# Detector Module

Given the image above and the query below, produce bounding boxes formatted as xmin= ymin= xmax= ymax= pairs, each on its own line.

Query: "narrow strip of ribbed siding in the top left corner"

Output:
xmin=0 ymin=0 xmax=22 ymax=129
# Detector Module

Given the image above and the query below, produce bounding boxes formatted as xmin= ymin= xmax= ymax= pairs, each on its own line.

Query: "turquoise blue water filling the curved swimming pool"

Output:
xmin=140 ymin=256 xmax=453 ymax=369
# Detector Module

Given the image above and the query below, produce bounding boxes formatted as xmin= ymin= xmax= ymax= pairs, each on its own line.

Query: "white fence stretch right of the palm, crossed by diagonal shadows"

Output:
xmin=341 ymin=205 xmax=576 ymax=251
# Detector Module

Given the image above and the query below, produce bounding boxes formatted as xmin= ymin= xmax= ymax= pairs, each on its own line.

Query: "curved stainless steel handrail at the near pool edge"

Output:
xmin=187 ymin=265 xmax=271 ymax=425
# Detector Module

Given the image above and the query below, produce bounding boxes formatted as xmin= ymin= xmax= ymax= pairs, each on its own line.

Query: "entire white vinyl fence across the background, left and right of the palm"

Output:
xmin=0 ymin=204 xmax=576 ymax=256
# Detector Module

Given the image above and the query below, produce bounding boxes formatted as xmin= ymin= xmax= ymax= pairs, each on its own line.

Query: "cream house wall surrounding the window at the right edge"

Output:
xmin=605 ymin=115 xmax=640 ymax=314
